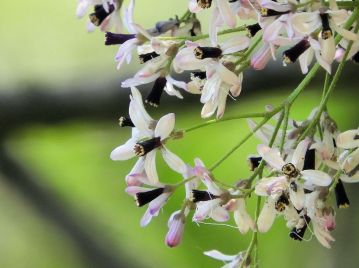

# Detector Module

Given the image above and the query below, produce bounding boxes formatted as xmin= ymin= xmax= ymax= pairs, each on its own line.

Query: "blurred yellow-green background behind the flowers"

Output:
xmin=0 ymin=0 xmax=359 ymax=267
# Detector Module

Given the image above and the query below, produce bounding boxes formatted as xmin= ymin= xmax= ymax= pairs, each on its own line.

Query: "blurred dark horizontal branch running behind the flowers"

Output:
xmin=0 ymin=62 xmax=356 ymax=135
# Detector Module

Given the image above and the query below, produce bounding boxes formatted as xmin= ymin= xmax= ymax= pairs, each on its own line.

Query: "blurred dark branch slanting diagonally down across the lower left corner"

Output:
xmin=0 ymin=145 xmax=139 ymax=268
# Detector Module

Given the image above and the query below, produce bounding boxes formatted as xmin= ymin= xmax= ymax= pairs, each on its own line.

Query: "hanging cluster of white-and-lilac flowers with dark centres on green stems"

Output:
xmin=77 ymin=0 xmax=359 ymax=267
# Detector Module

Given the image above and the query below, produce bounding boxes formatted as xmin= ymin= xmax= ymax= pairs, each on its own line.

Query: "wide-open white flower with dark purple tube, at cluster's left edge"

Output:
xmin=111 ymin=88 xmax=186 ymax=183
